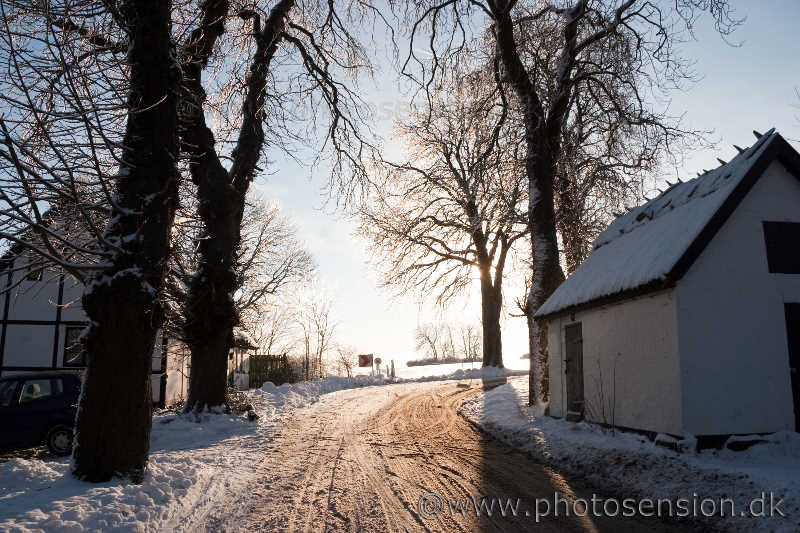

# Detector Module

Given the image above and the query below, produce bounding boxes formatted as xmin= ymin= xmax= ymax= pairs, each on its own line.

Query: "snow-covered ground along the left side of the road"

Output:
xmin=0 ymin=367 xmax=520 ymax=533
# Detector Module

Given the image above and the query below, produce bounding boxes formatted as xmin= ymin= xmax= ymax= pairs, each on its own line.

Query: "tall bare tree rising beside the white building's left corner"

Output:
xmin=402 ymin=0 xmax=740 ymax=403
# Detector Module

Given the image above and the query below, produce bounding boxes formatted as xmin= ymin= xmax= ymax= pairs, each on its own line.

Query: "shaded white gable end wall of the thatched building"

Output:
xmin=676 ymin=163 xmax=800 ymax=435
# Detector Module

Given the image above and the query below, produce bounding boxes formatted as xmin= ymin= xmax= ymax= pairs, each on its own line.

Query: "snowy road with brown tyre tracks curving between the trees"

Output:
xmin=205 ymin=380 xmax=692 ymax=532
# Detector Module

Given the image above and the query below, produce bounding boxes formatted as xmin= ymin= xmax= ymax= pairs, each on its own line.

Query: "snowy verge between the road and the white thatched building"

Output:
xmin=461 ymin=379 xmax=800 ymax=533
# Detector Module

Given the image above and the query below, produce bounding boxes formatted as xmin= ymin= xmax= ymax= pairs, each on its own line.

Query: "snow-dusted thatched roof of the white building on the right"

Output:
xmin=536 ymin=129 xmax=800 ymax=317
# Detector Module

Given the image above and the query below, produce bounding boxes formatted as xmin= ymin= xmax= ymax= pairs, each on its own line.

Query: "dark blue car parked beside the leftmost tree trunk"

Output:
xmin=0 ymin=372 xmax=81 ymax=455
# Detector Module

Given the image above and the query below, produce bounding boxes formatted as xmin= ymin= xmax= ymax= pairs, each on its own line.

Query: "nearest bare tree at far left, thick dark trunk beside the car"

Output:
xmin=0 ymin=0 xmax=180 ymax=482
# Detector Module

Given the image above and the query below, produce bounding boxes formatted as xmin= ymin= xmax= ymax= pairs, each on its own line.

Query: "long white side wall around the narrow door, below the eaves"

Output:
xmin=548 ymin=290 xmax=683 ymax=435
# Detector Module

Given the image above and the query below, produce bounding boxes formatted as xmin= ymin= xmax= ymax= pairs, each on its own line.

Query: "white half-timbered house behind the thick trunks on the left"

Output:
xmin=0 ymin=246 xmax=188 ymax=406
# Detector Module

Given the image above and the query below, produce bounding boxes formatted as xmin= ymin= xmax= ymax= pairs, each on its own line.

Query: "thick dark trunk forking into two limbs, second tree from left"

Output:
xmin=184 ymin=0 xmax=294 ymax=411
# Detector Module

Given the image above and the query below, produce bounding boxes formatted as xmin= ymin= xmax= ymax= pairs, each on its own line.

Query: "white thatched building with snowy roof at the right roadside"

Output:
xmin=536 ymin=130 xmax=800 ymax=439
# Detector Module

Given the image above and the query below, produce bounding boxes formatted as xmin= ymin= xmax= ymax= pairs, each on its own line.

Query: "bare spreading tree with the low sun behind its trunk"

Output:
xmin=360 ymin=69 xmax=527 ymax=366
